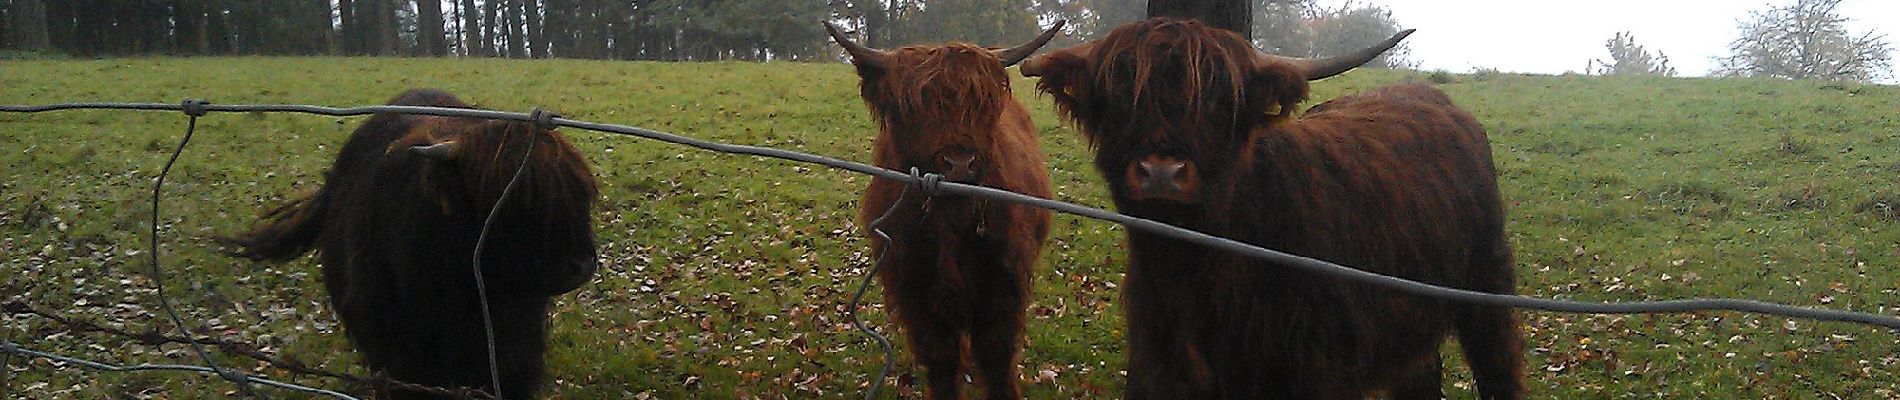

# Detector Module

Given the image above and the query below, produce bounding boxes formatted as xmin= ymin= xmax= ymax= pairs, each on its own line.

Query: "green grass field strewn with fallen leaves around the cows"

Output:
xmin=0 ymin=59 xmax=1900 ymax=398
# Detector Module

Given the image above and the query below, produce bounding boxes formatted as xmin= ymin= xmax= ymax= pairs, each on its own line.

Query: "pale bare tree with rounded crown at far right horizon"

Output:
xmin=1718 ymin=0 xmax=1892 ymax=82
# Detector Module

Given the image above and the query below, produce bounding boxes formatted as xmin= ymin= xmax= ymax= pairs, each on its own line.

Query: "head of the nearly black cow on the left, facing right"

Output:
xmin=391 ymin=118 xmax=599 ymax=296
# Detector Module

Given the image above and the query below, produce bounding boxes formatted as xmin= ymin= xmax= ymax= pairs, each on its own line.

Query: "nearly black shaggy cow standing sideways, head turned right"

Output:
xmin=230 ymin=89 xmax=597 ymax=398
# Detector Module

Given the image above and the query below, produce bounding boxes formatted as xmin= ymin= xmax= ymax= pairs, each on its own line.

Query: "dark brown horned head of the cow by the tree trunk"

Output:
xmin=1022 ymin=19 xmax=1412 ymax=205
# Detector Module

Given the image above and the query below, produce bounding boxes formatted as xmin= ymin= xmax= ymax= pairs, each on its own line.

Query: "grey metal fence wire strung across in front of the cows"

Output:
xmin=0 ymin=100 xmax=1900 ymax=398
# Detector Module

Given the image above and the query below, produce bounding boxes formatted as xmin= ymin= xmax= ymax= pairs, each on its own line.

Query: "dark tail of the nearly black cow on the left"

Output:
xmin=219 ymin=190 xmax=329 ymax=262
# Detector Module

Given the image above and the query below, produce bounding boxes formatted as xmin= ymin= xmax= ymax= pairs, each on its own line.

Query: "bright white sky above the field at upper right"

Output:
xmin=1319 ymin=0 xmax=1900 ymax=82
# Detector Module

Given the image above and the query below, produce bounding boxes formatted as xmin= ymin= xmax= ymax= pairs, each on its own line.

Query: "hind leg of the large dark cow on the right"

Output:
xmin=1452 ymin=305 xmax=1524 ymax=400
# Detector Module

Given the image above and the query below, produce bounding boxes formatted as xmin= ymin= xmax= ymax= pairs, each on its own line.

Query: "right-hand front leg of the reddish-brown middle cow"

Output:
xmin=969 ymin=271 xmax=1028 ymax=400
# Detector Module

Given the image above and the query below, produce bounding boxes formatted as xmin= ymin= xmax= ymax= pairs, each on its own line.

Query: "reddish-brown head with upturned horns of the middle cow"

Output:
xmin=825 ymin=21 xmax=1062 ymax=182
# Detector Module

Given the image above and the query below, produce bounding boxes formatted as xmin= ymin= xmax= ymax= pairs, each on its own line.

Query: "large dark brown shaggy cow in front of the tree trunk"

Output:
xmin=1022 ymin=19 xmax=1524 ymax=398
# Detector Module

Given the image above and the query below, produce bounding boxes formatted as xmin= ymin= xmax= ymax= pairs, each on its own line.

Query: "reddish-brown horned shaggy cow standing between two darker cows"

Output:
xmin=825 ymin=23 xmax=1060 ymax=398
